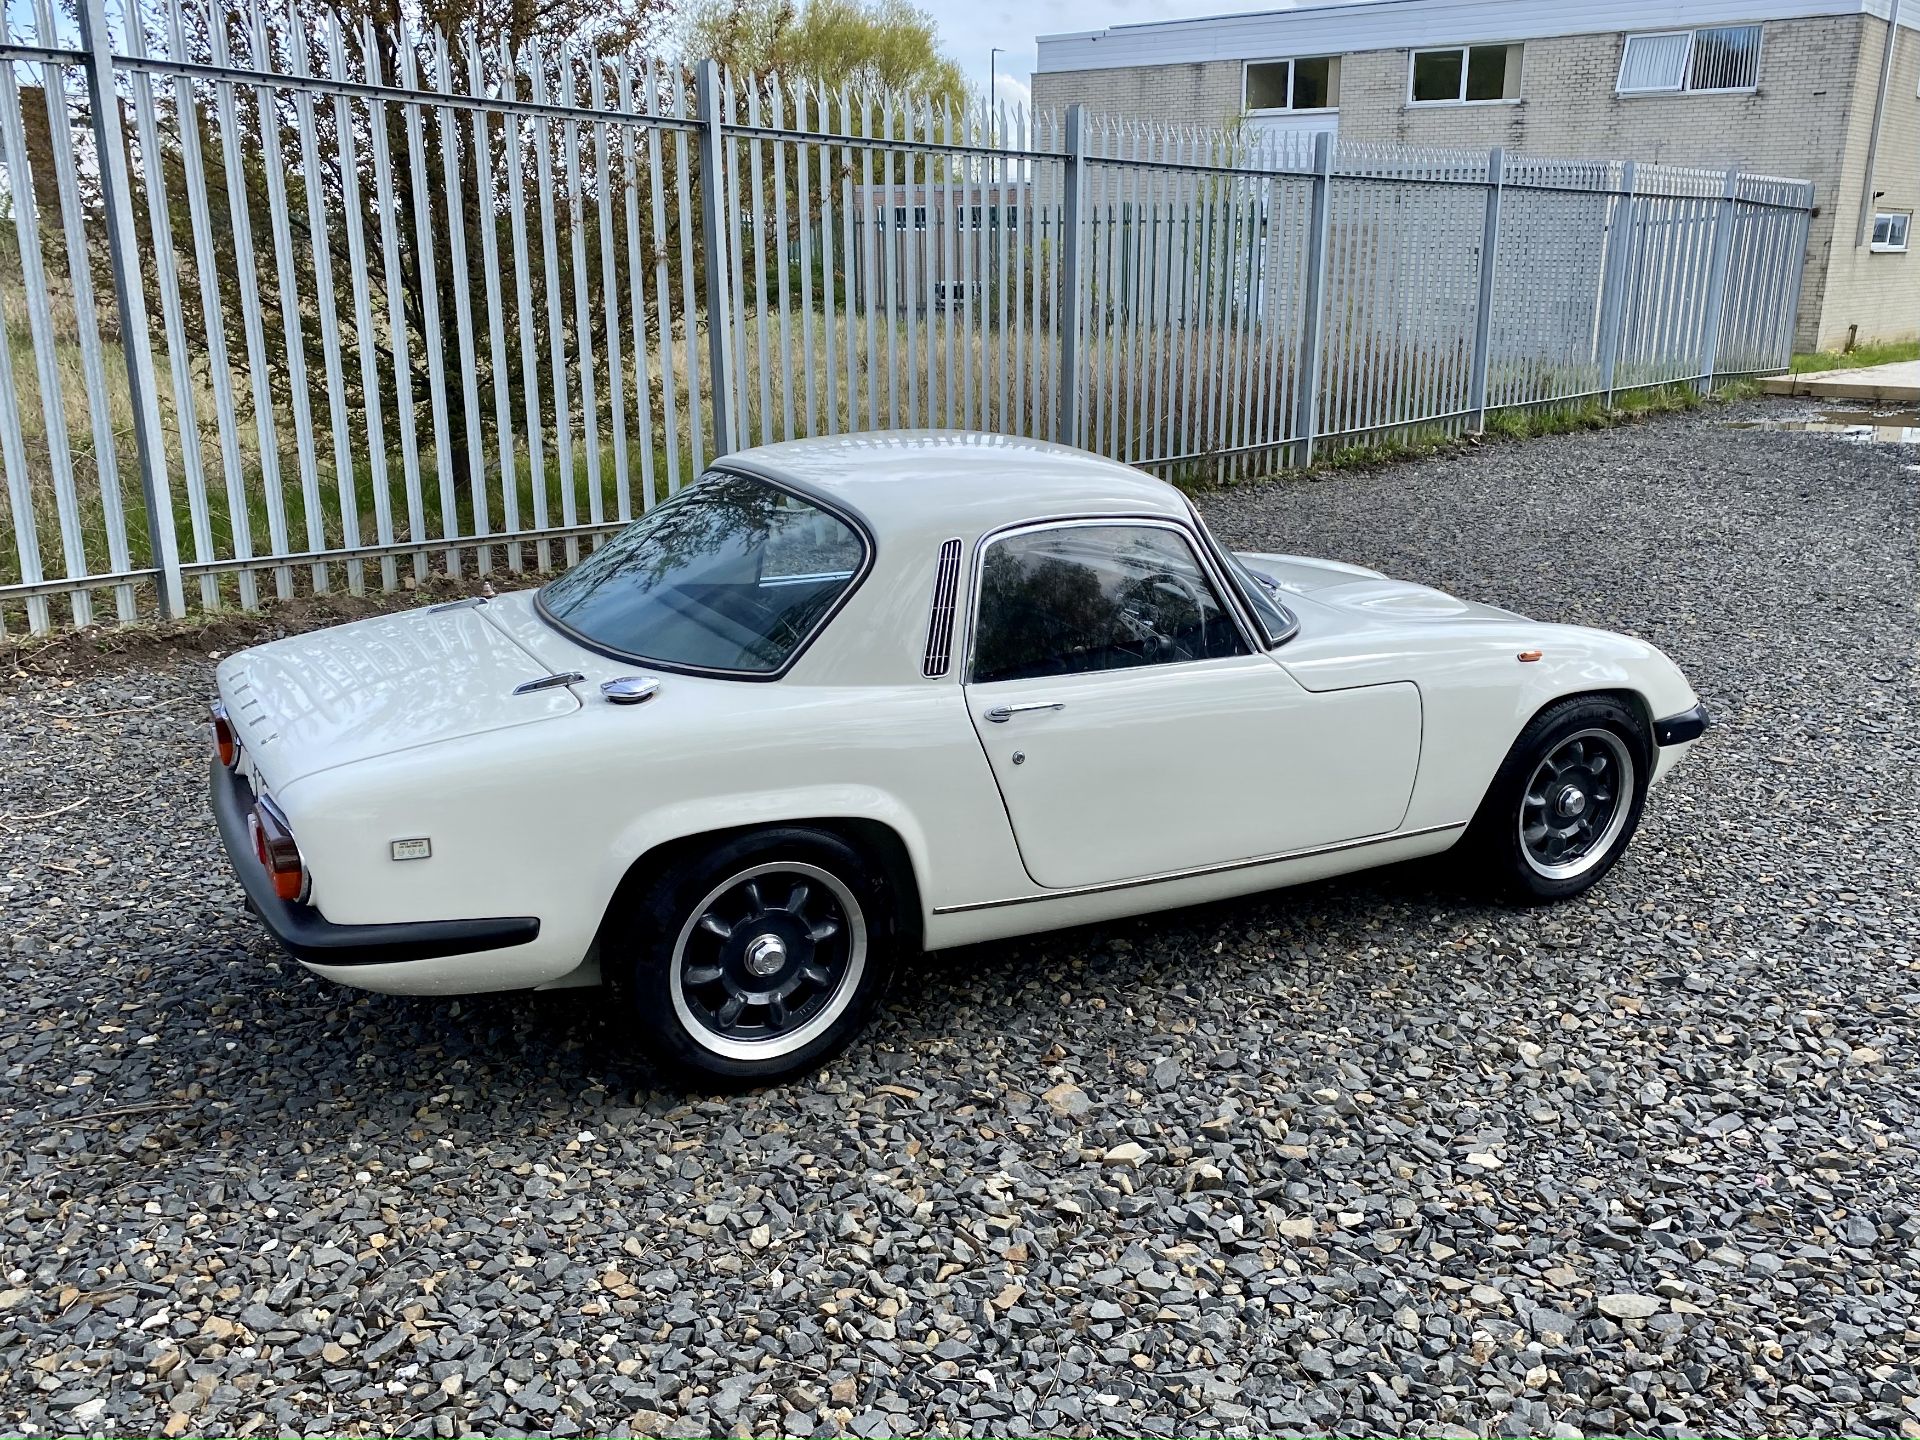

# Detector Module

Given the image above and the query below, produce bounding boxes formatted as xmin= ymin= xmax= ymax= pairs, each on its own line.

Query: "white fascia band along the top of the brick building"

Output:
xmin=1035 ymin=0 xmax=1920 ymax=73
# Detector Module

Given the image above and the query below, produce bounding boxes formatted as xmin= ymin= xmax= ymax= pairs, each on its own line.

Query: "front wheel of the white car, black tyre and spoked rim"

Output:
xmin=1461 ymin=695 xmax=1653 ymax=904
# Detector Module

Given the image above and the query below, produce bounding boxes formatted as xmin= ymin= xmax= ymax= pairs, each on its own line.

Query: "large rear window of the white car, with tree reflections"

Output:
xmin=540 ymin=470 xmax=866 ymax=674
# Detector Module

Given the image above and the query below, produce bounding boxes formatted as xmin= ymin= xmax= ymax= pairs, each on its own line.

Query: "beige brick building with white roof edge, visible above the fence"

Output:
xmin=1033 ymin=0 xmax=1920 ymax=348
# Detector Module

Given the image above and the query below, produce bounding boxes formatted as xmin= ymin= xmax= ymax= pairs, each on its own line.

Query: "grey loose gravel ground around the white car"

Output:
xmin=0 ymin=397 xmax=1920 ymax=1436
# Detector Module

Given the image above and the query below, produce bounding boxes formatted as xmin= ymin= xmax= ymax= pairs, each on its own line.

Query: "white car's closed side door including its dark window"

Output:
xmin=966 ymin=520 xmax=1421 ymax=889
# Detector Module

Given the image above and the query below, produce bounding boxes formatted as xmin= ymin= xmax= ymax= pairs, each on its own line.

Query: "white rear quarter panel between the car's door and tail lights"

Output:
xmin=276 ymin=676 xmax=1027 ymax=991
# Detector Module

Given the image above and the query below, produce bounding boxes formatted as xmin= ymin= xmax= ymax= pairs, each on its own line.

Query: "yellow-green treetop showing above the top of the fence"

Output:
xmin=685 ymin=0 xmax=968 ymax=111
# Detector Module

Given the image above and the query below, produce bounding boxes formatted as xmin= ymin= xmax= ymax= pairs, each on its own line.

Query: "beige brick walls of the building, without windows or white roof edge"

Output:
xmin=1033 ymin=15 xmax=1920 ymax=348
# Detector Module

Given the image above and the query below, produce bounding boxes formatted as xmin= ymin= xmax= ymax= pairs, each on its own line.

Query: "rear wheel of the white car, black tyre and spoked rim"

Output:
xmin=601 ymin=828 xmax=900 ymax=1089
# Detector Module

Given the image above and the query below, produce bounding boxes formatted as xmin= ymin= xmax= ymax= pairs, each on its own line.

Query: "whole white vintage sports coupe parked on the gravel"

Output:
xmin=211 ymin=432 xmax=1707 ymax=1083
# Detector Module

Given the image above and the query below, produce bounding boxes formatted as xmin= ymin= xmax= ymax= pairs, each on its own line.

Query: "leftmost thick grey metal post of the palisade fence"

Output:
xmin=79 ymin=0 xmax=186 ymax=620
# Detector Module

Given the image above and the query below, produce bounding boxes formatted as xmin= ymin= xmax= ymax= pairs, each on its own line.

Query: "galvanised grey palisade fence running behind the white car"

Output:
xmin=0 ymin=0 xmax=1812 ymax=634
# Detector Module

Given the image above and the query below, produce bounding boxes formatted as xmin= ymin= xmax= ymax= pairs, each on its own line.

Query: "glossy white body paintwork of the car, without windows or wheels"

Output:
xmin=219 ymin=434 xmax=1695 ymax=993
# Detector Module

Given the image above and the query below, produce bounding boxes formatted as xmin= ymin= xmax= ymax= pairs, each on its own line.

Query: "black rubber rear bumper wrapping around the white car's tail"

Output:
xmin=207 ymin=756 xmax=540 ymax=966
